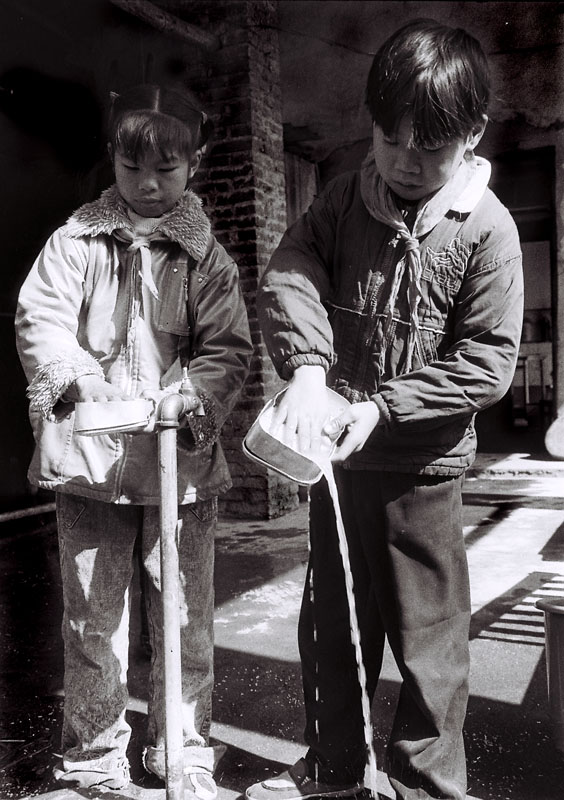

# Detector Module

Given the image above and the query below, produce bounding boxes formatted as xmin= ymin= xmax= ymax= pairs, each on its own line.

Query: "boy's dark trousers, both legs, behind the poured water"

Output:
xmin=298 ymin=468 xmax=470 ymax=800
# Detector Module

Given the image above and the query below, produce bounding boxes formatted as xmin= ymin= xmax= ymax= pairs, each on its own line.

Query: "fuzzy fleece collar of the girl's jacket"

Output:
xmin=66 ymin=185 xmax=211 ymax=261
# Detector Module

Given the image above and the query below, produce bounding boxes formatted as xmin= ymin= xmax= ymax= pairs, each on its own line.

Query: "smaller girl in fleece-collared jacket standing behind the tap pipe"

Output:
xmin=16 ymin=85 xmax=252 ymax=800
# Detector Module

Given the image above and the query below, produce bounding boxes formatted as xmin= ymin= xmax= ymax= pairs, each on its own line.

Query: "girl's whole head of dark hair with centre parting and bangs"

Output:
xmin=108 ymin=84 xmax=212 ymax=161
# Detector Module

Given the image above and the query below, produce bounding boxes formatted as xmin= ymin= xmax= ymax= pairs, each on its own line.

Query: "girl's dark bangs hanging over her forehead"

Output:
xmin=114 ymin=111 xmax=193 ymax=161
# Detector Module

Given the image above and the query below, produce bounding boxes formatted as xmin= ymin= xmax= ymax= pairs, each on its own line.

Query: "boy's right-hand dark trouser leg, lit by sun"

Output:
xmin=355 ymin=473 xmax=470 ymax=800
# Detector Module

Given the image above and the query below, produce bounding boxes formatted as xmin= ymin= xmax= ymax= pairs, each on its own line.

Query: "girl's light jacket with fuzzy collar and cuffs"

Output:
xmin=16 ymin=187 xmax=252 ymax=505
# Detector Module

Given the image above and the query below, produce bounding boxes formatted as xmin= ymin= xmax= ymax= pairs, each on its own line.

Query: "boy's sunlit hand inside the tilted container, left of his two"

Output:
xmin=272 ymin=365 xmax=328 ymax=453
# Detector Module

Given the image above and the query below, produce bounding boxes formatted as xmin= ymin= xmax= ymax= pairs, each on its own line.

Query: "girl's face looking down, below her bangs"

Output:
xmin=114 ymin=152 xmax=195 ymax=217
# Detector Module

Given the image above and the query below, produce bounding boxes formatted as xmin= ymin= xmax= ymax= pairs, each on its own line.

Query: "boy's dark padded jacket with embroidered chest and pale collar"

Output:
xmin=257 ymin=155 xmax=523 ymax=475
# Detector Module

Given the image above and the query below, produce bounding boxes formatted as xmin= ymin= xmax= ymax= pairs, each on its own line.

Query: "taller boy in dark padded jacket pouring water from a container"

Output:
xmin=247 ymin=20 xmax=523 ymax=800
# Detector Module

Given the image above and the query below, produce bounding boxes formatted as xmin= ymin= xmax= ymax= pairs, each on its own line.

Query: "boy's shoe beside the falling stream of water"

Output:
xmin=245 ymin=758 xmax=364 ymax=800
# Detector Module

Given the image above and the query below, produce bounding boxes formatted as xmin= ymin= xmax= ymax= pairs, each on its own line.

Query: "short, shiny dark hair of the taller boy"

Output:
xmin=366 ymin=19 xmax=490 ymax=149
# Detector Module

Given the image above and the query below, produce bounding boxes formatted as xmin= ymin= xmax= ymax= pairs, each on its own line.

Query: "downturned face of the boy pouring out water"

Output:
xmin=373 ymin=115 xmax=485 ymax=203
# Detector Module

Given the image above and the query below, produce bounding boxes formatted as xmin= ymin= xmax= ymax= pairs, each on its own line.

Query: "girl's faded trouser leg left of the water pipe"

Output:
xmin=56 ymin=493 xmax=139 ymax=772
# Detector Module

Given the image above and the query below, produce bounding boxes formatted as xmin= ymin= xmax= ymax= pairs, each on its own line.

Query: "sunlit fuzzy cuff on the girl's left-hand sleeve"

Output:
xmin=27 ymin=348 xmax=105 ymax=419
